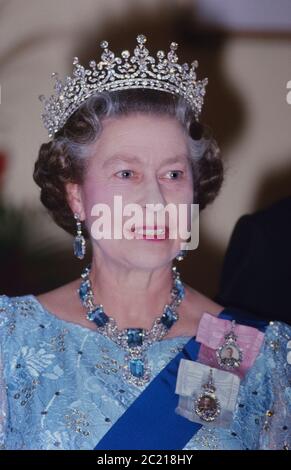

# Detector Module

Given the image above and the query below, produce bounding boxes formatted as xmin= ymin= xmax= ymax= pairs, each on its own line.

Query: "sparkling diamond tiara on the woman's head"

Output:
xmin=39 ymin=34 xmax=208 ymax=137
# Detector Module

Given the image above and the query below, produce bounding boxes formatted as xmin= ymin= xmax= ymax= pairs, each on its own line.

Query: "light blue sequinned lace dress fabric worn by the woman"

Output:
xmin=0 ymin=295 xmax=291 ymax=450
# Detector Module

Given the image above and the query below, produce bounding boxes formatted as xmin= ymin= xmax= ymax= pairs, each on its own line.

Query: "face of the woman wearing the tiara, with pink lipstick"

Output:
xmin=76 ymin=113 xmax=193 ymax=269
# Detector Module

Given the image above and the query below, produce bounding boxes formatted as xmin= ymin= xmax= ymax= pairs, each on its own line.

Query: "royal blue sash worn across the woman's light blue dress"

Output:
xmin=94 ymin=309 xmax=267 ymax=450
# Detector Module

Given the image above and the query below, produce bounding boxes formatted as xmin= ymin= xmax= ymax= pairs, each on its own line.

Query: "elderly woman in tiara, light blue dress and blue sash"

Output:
xmin=0 ymin=35 xmax=290 ymax=449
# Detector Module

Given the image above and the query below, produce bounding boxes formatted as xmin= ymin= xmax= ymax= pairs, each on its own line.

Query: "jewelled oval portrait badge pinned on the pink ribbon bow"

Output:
xmin=216 ymin=320 xmax=243 ymax=370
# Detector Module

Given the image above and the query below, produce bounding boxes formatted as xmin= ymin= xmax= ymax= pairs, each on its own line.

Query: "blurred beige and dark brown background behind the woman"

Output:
xmin=0 ymin=0 xmax=291 ymax=296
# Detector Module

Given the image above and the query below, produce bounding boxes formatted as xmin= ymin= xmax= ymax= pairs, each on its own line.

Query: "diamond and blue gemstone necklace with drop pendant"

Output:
xmin=78 ymin=265 xmax=185 ymax=386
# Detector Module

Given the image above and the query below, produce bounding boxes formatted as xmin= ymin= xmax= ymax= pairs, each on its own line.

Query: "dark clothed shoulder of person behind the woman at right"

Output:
xmin=215 ymin=198 xmax=291 ymax=323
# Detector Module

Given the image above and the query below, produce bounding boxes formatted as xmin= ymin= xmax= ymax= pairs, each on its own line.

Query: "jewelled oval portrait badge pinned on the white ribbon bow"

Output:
xmin=194 ymin=369 xmax=221 ymax=422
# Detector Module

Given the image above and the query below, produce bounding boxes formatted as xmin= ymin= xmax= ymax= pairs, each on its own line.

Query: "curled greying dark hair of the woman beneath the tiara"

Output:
xmin=33 ymin=89 xmax=223 ymax=237
